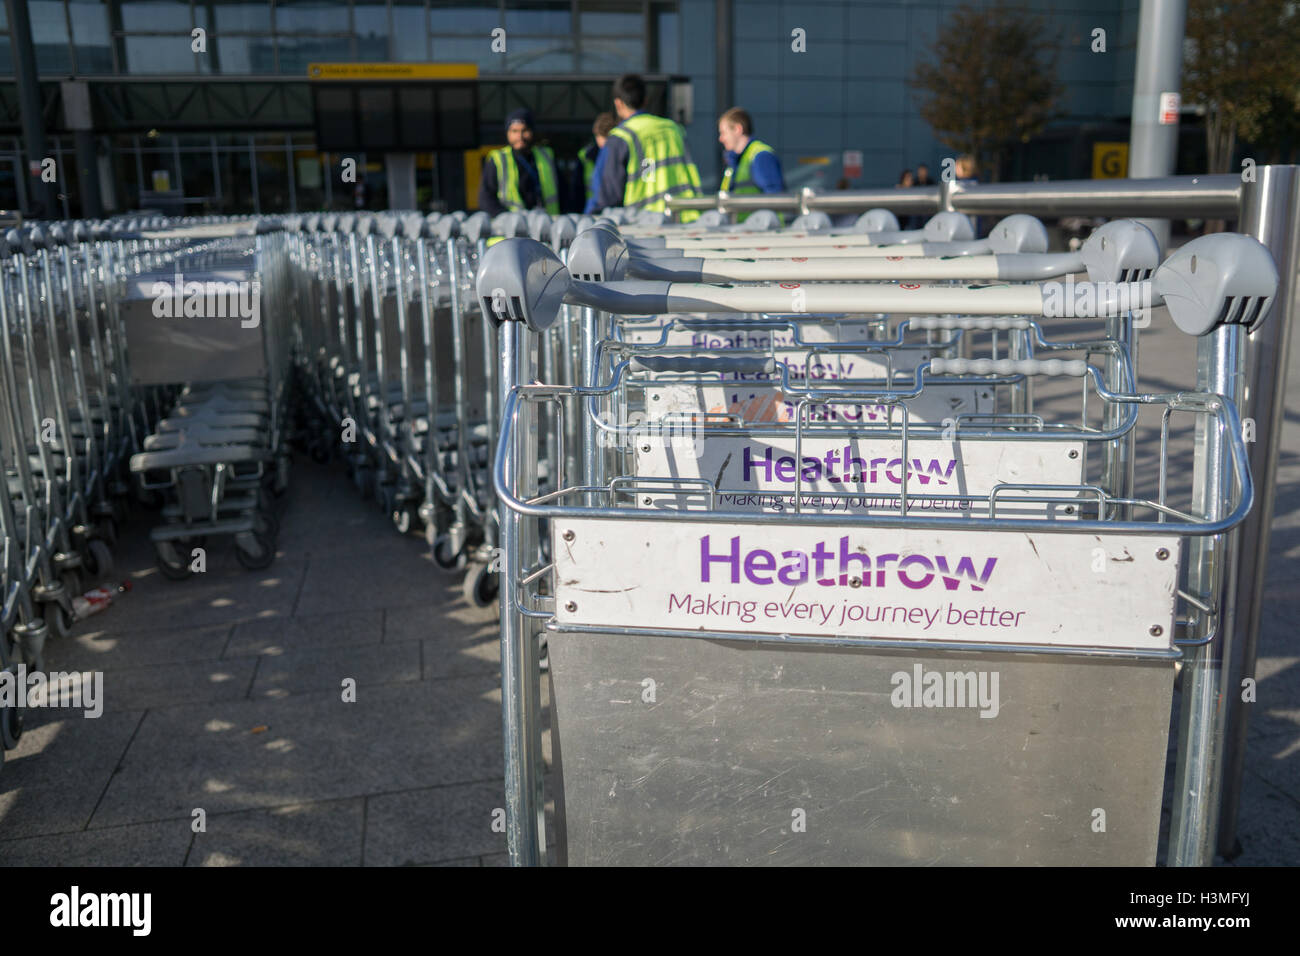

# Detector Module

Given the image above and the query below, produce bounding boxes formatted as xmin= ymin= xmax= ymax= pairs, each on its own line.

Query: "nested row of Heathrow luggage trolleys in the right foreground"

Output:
xmin=477 ymin=209 xmax=1277 ymax=864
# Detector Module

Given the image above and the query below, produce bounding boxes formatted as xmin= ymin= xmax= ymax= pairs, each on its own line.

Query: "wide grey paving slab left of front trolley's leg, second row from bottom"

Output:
xmin=92 ymin=676 xmax=502 ymax=826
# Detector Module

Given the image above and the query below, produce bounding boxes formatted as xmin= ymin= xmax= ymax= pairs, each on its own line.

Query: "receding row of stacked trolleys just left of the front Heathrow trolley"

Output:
xmin=286 ymin=213 xmax=592 ymax=606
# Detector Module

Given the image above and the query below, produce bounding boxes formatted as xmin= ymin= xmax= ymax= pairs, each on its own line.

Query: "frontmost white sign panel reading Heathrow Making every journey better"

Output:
xmin=553 ymin=518 xmax=1179 ymax=649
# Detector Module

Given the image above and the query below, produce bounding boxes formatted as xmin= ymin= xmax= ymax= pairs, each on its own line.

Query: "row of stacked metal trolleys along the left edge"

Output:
xmin=0 ymin=220 xmax=287 ymax=770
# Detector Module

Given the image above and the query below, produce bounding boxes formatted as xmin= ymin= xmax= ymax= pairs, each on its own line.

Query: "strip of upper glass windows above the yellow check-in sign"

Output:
xmin=0 ymin=0 xmax=679 ymax=77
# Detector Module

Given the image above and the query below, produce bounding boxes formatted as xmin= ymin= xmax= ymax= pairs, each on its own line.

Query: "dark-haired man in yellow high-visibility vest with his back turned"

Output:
xmin=585 ymin=73 xmax=699 ymax=222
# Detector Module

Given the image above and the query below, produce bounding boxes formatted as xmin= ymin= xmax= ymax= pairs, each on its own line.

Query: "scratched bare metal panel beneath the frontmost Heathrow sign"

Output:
xmin=549 ymin=633 xmax=1174 ymax=866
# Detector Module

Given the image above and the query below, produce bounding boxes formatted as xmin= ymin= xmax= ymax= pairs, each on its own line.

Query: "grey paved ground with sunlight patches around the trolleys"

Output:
xmin=0 ymin=304 xmax=1300 ymax=866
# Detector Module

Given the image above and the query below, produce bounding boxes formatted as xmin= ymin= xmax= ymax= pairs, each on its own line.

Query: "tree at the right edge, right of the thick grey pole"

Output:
xmin=1183 ymin=0 xmax=1300 ymax=173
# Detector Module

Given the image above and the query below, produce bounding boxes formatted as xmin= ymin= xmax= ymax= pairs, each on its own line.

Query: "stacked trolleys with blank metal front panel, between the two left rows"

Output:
xmin=117 ymin=220 xmax=291 ymax=580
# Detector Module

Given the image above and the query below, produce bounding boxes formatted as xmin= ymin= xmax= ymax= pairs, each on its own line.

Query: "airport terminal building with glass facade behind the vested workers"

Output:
xmin=0 ymin=0 xmax=1159 ymax=216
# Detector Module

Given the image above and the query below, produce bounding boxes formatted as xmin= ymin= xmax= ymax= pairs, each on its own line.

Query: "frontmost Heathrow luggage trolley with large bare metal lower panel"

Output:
xmin=478 ymin=235 xmax=1277 ymax=864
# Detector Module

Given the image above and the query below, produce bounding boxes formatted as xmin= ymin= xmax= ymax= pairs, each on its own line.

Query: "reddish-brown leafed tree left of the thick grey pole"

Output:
xmin=910 ymin=3 xmax=1063 ymax=181
